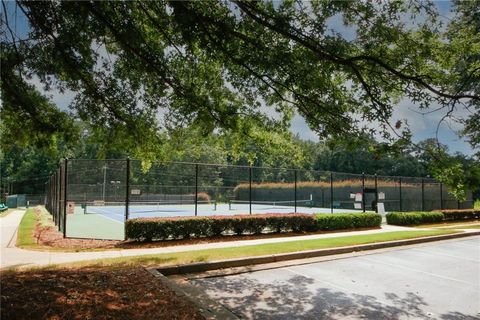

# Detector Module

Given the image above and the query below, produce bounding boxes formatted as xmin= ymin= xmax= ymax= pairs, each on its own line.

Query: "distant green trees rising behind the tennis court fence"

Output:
xmin=0 ymin=122 xmax=480 ymax=198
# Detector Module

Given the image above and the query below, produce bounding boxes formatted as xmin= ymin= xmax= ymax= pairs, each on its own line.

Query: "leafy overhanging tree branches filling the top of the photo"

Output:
xmin=1 ymin=0 xmax=480 ymax=199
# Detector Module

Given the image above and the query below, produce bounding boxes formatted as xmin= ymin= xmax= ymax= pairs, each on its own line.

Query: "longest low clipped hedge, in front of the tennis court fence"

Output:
xmin=125 ymin=213 xmax=381 ymax=241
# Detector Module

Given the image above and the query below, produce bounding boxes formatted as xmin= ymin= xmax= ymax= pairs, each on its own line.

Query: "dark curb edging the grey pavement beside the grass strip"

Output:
xmin=153 ymin=231 xmax=480 ymax=276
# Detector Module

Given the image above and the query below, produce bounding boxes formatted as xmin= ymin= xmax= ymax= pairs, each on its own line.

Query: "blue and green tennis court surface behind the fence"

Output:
xmin=66 ymin=200 xmax=358 ymax=240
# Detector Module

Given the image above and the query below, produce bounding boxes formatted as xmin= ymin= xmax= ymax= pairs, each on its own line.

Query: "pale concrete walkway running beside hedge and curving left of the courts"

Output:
xmin=0 ymin=210 xmax=472 ymax=268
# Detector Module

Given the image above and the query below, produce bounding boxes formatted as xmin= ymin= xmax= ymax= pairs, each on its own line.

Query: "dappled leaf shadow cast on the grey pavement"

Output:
xmin=192 ymin=276 xmax=478 ymax=320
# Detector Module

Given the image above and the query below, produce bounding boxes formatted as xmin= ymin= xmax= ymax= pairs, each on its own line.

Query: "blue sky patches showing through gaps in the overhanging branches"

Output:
xmin=2 ymin=1 xmax=473 ymax=155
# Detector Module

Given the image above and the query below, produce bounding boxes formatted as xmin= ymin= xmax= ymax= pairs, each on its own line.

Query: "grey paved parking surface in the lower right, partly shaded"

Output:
xmin=191 ymin=237 xmax=480 ymax=320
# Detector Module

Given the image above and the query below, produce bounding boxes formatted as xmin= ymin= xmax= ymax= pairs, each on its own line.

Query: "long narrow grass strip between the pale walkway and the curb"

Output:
xmin=47 ymin=230 xmax=458 ymax=268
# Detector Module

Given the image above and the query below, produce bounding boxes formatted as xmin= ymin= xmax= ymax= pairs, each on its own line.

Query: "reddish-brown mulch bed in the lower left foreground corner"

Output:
xmin=0 ymin=267 xmax=204 ymax=320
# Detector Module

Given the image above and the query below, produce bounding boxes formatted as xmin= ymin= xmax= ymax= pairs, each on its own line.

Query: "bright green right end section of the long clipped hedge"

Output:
xmin=316 ymin=213 xmax=382 ymax=230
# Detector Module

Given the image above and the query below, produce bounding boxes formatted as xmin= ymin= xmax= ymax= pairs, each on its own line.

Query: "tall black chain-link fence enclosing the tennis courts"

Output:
xmin=45 ymin=159 xmax=473 ymax=239
